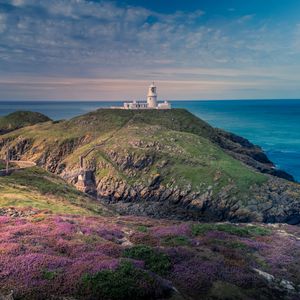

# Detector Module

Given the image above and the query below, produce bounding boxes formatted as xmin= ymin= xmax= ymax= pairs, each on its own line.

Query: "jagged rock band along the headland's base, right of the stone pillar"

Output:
xmin=97 ymin=172 xmax=300 ymax=224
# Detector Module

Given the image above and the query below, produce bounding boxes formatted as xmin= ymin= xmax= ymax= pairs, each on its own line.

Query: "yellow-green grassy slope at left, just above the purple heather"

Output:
xmin=0 ymin=167 xmax=112 ymax=215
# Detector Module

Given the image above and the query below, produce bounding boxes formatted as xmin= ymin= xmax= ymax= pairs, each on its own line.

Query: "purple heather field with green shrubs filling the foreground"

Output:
xmin=0 ymin=214 xmax=300 ymax=300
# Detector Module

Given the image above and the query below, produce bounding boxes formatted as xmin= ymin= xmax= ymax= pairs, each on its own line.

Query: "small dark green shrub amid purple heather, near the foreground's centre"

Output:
xmin=124 ymin=245 xmax=171 ymax=275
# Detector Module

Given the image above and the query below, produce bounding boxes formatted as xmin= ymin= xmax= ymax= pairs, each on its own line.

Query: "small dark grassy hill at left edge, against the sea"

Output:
xmin=0 ymin=111 xmax=51 ymax=134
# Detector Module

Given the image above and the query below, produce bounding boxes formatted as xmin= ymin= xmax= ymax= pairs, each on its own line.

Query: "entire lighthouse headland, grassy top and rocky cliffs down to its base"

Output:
xmin=0 ymin=109 xmax=300 ymax=224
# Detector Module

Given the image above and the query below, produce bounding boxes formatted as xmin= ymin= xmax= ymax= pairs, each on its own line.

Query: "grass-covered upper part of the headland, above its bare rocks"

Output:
xmin=1 ymin=109 xmax=265 ymax=188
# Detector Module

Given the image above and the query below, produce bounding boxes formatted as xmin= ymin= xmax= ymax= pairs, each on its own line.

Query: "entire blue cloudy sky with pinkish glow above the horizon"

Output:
xmin=0 ymin=0 xmax=300 ymax=101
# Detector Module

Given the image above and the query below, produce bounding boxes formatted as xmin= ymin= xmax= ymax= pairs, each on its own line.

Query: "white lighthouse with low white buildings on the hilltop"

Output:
xmin=123 ymin=82 xmax=171 ymax=109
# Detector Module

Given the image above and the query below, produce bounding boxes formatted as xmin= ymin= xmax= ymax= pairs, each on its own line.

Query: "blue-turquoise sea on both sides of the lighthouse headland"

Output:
xmin=0 ymin=100 xmax=300 ymax=181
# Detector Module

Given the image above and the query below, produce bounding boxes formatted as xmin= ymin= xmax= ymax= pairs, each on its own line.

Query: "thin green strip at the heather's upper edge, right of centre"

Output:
xmin=192 ymin=223 xmax=272 ymax=237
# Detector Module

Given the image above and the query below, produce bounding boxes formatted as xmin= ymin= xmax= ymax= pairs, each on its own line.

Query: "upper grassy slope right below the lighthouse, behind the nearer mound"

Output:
xmin=4 ymin=109 xmax=215 ymax=141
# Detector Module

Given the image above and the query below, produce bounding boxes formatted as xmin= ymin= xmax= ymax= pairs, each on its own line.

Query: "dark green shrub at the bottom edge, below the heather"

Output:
xmin=82 ymin=261 xmax=169 ymax=300
